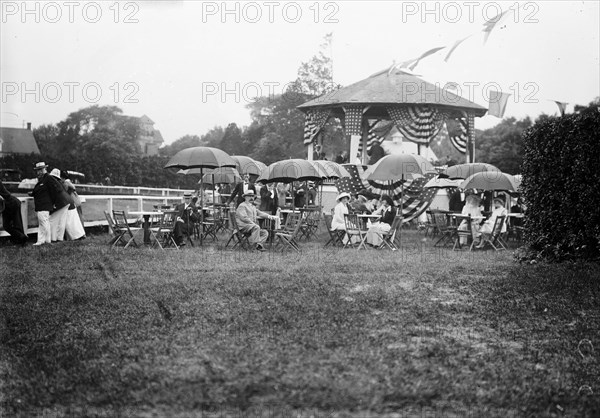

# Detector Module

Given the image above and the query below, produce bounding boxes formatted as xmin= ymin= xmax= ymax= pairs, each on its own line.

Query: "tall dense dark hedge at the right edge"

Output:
xmin=522 ymin=109 xmax=600 ymax=261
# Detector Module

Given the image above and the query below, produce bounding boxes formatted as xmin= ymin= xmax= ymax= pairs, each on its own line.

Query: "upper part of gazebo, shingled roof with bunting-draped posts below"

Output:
xmin=298 ymin=69 xmax=487 ymax=163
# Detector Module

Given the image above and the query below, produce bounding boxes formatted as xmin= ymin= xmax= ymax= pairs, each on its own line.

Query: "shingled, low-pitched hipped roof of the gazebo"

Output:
xmin=298 ymin=70 xmax=487 ymax=116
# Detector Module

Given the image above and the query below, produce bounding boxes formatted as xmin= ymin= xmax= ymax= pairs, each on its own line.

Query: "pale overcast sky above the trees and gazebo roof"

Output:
xmin=0 ymin=1 xmax=600 ymax=142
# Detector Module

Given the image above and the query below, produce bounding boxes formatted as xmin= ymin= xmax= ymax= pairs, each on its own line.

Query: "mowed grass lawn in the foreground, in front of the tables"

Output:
xmin=0 ymin=231 xmax=600 ymax=417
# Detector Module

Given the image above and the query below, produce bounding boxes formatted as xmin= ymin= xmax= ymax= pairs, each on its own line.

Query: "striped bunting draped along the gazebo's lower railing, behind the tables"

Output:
xmin=336 ymin=164 xmax=437 ymax=222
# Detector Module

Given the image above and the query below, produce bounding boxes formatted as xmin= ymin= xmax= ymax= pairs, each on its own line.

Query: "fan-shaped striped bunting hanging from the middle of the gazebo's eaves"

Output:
xmin=386 ymin=105 xmax=446 ymax=146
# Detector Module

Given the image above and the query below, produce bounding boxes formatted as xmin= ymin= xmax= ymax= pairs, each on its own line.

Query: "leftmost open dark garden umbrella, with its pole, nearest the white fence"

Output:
xmin=163 ymin=147 xmax=235 ymax=245
